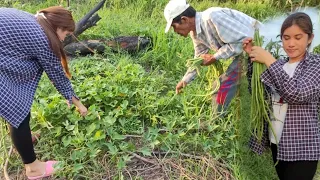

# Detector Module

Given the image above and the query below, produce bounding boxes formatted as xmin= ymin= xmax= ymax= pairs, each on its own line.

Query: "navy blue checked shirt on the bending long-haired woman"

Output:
xmin=0 ymin=8 xmax=75 ymax=128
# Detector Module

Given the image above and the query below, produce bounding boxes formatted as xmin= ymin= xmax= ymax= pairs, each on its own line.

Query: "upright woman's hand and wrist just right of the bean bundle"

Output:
xmin=249 ymin=46 xmax=276 ymax=67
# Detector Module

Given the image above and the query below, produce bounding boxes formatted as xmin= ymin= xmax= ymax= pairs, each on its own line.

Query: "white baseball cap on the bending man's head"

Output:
xmin=164 ymin=0 xmax=190 ymax=33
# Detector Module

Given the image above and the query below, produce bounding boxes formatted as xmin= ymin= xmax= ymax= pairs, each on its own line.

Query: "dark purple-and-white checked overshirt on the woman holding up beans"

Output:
xmin=247 ymin=53 xmax=320 ymax=161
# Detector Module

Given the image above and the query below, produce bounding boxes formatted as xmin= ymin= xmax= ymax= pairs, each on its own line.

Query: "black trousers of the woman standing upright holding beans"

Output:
xmin=271 ymin=144 xmax=318 ymax=180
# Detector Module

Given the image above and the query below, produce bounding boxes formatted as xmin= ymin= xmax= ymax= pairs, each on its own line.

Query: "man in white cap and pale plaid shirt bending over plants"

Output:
xmin=164 ymin=0 xmax=260 ymax=112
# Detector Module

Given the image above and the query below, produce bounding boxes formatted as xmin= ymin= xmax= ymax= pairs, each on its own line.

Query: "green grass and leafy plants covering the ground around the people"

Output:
xmin=0 ymin=0 xmax=316 ymax=180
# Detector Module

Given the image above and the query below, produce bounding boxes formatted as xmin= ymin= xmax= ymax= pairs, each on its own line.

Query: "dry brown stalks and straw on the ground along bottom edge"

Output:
xmin=0 ymin=152 xmax=235 ymax=180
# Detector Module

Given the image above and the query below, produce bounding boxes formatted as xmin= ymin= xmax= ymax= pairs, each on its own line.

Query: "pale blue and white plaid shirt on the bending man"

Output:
xmin=182 ymin=7 xmax=261 ymax=83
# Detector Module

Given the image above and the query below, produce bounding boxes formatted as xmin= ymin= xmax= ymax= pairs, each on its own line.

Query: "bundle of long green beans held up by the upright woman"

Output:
xmin=250 ymin=30 xmax=274 ymax=141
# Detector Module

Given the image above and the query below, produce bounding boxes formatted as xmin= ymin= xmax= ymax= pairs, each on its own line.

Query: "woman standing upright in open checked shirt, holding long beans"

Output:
xmin=243 ymin=12 xmax=320 ymax=180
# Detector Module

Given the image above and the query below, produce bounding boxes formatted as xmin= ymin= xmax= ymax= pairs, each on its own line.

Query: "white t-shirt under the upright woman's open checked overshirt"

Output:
xmin=269 ymin=62 xmax=299 ymax=144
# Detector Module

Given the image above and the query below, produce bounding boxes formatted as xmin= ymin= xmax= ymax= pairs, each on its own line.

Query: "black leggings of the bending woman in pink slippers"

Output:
xmin=9 ymin=113 xmax=36 ymax=164
